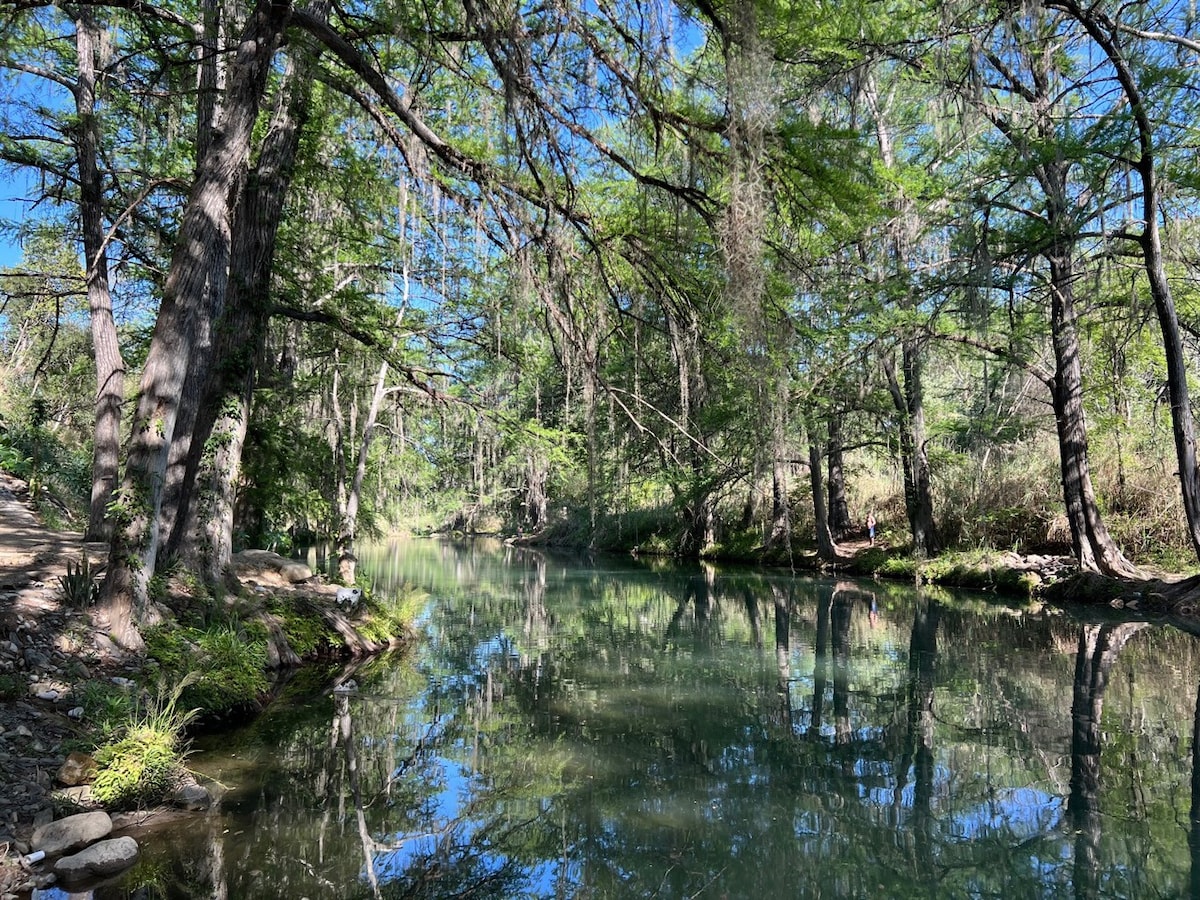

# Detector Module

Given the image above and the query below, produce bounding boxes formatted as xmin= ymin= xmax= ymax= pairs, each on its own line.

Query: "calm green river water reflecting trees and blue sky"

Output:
xmin=70 ymin=541 xmax=1200 ymax=900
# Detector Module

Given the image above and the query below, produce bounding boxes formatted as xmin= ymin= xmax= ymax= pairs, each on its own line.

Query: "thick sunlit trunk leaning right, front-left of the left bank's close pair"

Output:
xmin=98 ymin=0 xmax=289 ymax=649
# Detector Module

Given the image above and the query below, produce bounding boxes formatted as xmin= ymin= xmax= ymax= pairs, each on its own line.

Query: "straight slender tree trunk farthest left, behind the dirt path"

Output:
xmin=74 ymin=6 xmax=125 ymax=540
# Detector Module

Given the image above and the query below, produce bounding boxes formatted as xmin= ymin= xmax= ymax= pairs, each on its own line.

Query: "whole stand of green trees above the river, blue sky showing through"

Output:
xmin=0 ymin=0 xmax=1200 ymax=646
